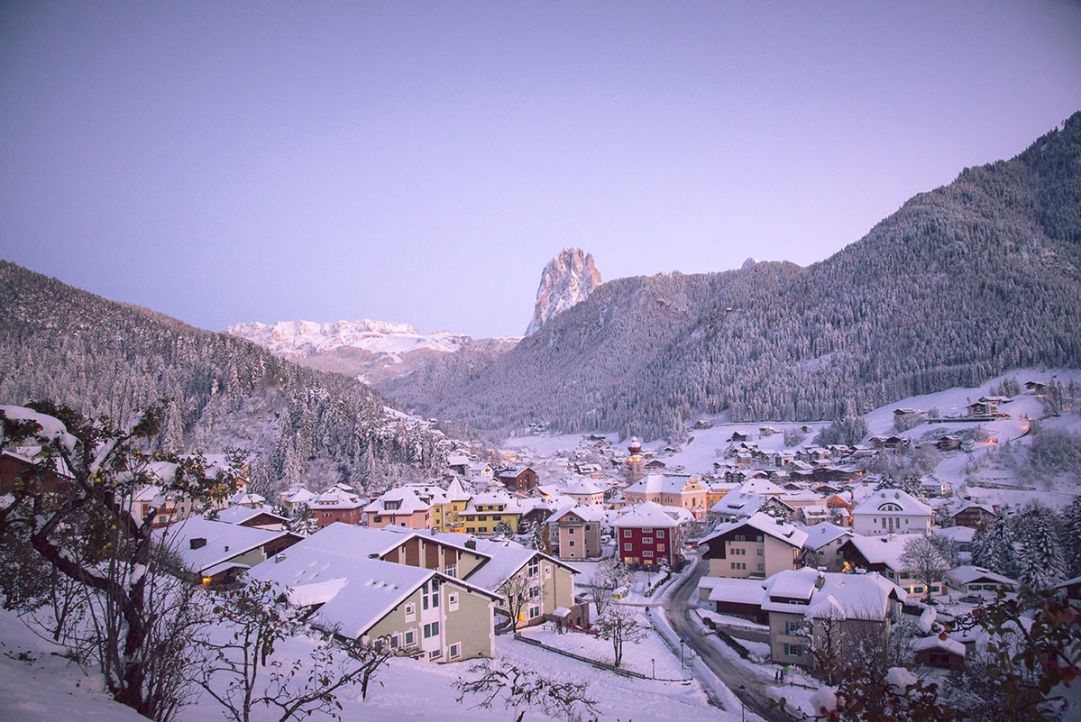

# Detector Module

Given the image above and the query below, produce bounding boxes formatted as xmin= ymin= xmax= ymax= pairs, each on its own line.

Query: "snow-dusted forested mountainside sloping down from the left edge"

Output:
xmin=0 ymin=262 xmax=448 ymax=489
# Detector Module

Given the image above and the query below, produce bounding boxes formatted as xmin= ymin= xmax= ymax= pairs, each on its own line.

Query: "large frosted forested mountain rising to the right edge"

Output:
xmin=385 ymin=113 xmax=1081 ymax=437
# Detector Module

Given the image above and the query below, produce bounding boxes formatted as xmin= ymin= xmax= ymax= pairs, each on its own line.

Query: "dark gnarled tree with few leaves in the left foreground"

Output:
xmin=0 ymin=402 xmax=238 ymax=720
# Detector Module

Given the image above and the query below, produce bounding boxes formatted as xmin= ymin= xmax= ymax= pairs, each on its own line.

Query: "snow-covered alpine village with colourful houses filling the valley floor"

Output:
xmin=0 ymin=371 xmax=1081 ymax=719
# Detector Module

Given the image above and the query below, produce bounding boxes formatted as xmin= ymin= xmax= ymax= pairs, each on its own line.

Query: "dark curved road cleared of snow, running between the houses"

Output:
xmin=664 ymin=560 xmax=793 ymax=722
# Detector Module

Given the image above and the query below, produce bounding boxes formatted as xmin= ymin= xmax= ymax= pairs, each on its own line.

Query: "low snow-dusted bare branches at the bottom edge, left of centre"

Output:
xmin=454 ymin=657 xmax=598 ymax=722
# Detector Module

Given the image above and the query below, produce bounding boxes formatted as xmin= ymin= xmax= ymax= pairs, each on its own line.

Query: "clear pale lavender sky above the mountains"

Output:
xmin=0 ymin=0 xmax=1081 ymax=336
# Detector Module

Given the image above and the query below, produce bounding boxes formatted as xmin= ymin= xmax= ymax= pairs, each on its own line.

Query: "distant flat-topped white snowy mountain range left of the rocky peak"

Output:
xmin=225 ymin=319 xmax=519 ymax=386
